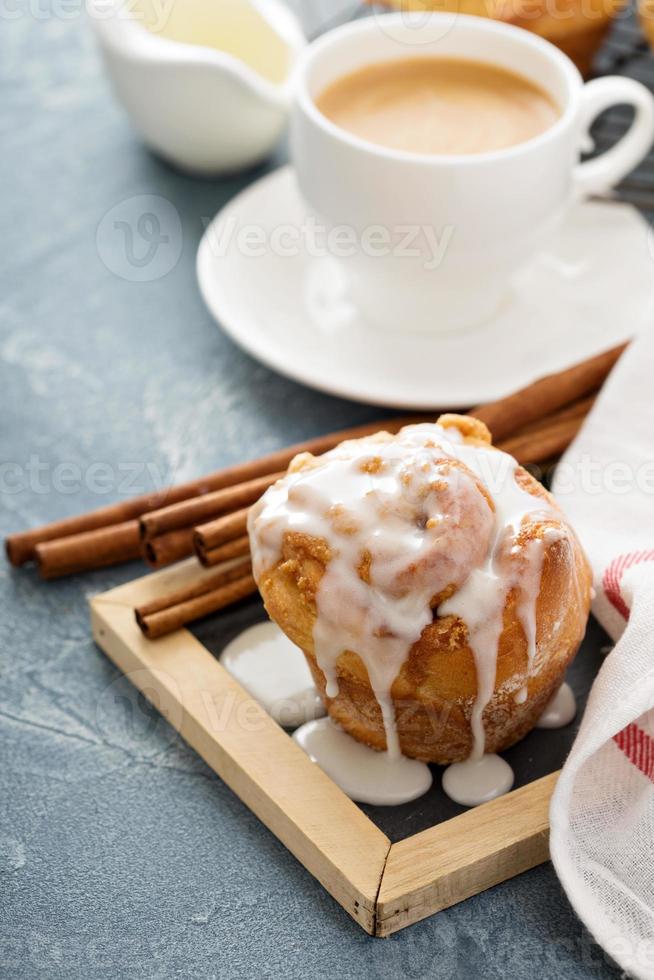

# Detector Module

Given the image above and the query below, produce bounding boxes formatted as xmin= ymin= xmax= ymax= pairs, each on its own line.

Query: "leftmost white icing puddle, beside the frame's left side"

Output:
xmin=220 ymin=622 xmax=325 ymax=728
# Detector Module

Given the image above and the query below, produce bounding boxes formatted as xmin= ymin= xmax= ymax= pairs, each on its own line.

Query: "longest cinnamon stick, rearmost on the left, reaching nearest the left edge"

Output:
xmin=5 ymin=415 xmax=426 ymax=565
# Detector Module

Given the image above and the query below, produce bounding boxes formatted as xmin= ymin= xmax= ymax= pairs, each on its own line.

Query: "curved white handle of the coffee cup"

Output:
xmin=574 ymin=75 xmax=654 ymax=197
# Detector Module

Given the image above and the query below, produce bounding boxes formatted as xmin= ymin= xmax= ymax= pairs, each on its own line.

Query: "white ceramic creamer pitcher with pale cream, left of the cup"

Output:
xmin=87 ymin=0 xmax=306 ymax=174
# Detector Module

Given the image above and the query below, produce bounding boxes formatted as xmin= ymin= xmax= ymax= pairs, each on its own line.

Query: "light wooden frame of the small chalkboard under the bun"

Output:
xmin=90 ymin=561 xmax=558 ymax=936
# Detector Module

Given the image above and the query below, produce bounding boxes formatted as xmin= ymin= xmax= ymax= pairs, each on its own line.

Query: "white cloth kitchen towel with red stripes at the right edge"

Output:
xmin=551 ymin=329 xmax=654 ymax=980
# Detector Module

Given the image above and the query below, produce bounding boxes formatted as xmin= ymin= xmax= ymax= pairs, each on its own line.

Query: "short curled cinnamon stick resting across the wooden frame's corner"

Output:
xmin=134 ymin=560 xmax=257 ymax=640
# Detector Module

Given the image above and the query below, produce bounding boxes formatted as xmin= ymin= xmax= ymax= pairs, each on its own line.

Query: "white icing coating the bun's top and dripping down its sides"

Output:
xmin=249 ymin=424 xmax=561 ymax=759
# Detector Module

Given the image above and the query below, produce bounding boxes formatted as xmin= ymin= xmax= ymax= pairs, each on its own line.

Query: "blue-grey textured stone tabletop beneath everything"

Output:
xmin=0 ymin=0 xmax=614 ymax=980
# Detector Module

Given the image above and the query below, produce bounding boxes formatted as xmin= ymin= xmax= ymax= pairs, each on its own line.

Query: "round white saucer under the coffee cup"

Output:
xmin=197 ymin=167 xmax=654 ymax=408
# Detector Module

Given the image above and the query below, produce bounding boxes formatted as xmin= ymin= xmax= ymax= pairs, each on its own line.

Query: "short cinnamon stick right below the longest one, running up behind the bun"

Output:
xmin=140 ymin=471 xmax=285 ymax=541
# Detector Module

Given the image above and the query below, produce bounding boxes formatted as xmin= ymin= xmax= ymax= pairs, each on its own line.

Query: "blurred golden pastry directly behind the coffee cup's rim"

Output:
xmin=368 ymin=0 xmax=632 ymax=75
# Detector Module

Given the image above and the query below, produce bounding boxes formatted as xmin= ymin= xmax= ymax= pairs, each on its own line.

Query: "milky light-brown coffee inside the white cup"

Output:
xmin=316 ymin=57 xmax=560 ymax=154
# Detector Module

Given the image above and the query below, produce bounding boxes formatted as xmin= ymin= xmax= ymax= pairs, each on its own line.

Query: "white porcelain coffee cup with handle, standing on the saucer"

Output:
xmin=291 ymin=13 xmax=654 ymax=331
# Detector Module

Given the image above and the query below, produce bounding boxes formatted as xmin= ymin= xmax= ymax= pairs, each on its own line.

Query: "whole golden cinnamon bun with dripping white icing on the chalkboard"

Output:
xmin=249 ymin=415 xmax=591 ymax=763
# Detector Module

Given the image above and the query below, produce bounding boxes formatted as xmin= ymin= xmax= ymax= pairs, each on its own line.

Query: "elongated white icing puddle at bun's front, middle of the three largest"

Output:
xmin=293 ymin=718 xmax=432 ymax=806
